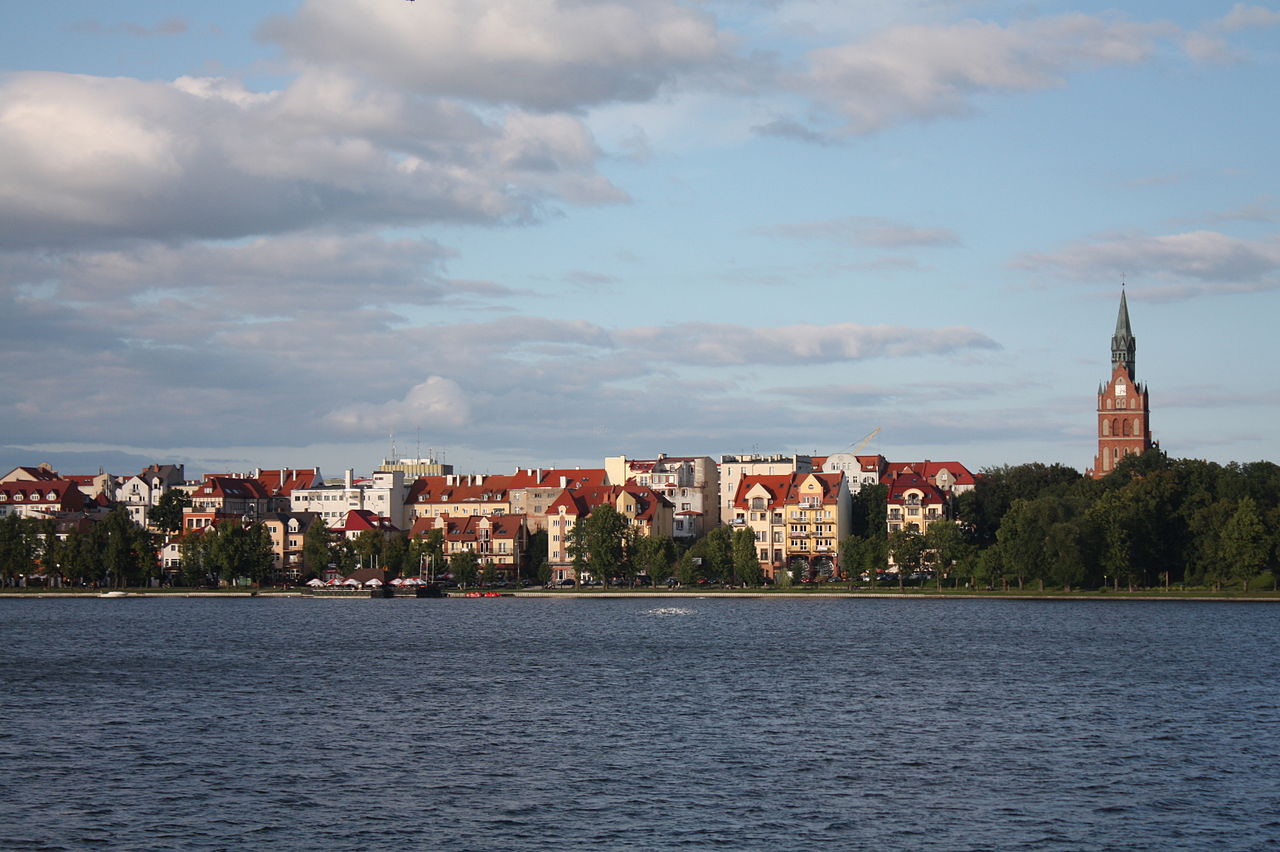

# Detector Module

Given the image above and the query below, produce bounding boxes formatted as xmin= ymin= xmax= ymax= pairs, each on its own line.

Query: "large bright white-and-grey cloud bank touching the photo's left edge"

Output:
xmin=0 ymin=72 xmax=625 ymax=247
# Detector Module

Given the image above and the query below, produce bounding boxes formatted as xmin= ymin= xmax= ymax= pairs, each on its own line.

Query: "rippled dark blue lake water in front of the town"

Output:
xmin=0 ymin=597 xmax=1280 ymax=851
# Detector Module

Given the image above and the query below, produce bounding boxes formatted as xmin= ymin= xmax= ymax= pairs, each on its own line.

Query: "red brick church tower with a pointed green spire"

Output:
xmin=1089 ymin=289 xmax=1155 ymax=478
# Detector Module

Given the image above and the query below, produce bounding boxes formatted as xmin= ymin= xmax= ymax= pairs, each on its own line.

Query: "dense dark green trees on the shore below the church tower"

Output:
xmin=860 ymin=450 xmax=1280 ymax=590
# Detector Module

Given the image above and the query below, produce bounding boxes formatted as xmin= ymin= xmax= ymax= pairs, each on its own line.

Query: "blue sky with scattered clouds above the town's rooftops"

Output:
xmin=0 ymin=0 xmax=1280 ymax=476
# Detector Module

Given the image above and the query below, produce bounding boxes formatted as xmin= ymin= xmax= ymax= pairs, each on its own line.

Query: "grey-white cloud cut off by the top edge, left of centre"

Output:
xmin=260 ymin=0 xmax=727 ymax=110
